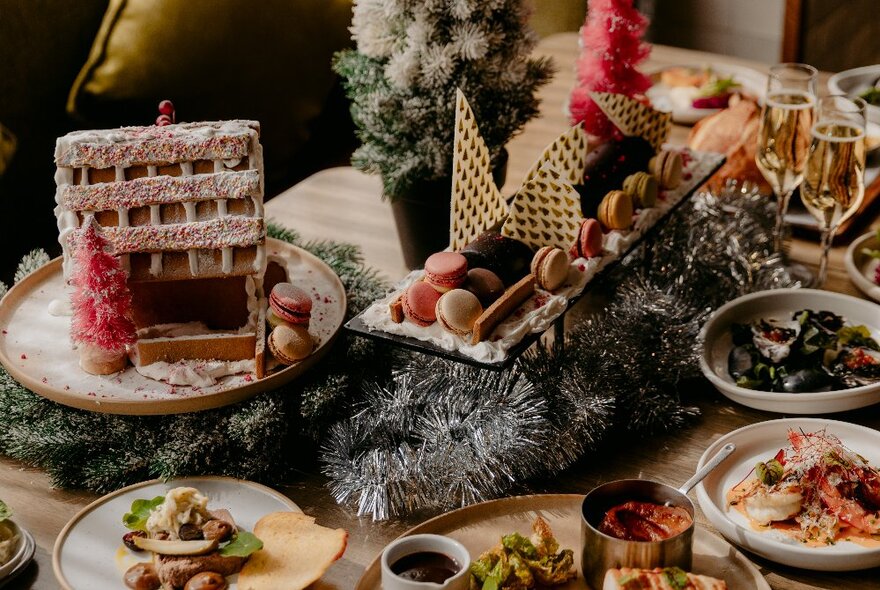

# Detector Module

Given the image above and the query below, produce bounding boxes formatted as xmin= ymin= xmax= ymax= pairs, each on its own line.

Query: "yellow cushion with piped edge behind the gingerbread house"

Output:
xmin=67 ymin=0 xmax=351 ymax=186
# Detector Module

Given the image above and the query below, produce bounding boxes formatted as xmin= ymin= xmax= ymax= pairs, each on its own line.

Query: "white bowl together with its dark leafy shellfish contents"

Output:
xmin=700 ymin=289 xmax=880 ymax=414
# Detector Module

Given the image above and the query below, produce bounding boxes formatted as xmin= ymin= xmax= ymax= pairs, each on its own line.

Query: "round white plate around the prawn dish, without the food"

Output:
xmin=697 ymin=418 xmax=880 ymax=571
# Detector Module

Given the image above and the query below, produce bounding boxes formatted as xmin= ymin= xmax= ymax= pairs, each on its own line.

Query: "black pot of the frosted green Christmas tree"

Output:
xmin=391 ymin=149 xmax=508 ymax=269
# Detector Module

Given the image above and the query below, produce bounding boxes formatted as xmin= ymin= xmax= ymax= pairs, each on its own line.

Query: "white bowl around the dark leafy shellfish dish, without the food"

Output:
xmin=700 ymin=289 xmax=880 ymax=414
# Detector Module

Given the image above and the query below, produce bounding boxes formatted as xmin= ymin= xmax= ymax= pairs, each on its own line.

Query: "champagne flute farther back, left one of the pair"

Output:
xmin=755 ymin=63 xmax=816 ymax=251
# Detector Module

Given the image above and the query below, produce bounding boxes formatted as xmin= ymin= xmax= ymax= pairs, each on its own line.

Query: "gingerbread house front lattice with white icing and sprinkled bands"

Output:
xmin=56 ymin=121 xmax=265 ymax=280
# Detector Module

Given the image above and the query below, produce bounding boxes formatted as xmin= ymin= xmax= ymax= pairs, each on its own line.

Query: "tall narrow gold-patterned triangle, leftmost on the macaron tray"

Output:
xmin=449 ymin=89 xmax=507 ymax=250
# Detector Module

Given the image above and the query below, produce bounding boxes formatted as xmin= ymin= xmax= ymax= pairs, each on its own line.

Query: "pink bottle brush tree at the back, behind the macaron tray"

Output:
xmin=569 ymin=0 xmax=651 ymax=138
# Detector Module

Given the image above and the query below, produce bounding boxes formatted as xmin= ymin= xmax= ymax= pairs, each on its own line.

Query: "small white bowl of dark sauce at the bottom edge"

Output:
xmin=382 ymin=535 xmax=471 ymax=590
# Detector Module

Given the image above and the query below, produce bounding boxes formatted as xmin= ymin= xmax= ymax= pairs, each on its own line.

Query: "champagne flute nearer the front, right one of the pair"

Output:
xmin=801 ymin=96 xmax=866 ymax=286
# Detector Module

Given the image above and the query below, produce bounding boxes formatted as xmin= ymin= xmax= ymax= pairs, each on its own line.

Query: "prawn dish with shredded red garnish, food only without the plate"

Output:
xmin=727 ymin=429 xmax=880 ymax=547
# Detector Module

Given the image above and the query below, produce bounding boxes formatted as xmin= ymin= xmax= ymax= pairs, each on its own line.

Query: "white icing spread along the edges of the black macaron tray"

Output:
xmin=359 ymin=150 xmax=724 ymax=363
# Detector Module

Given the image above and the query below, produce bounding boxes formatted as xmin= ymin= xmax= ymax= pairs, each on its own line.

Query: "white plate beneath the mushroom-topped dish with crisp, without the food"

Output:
xmin=52 ymin=477 xmax=302 ymax=590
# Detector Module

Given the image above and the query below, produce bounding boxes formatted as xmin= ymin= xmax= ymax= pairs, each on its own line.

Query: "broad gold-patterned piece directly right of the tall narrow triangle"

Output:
xmin=501 ymin=168 xmax=583 ymax=250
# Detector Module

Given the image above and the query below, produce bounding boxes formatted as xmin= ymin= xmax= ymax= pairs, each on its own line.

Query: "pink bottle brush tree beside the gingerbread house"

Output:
xmin=70 ymin=217 xmax=135 ymax=375
